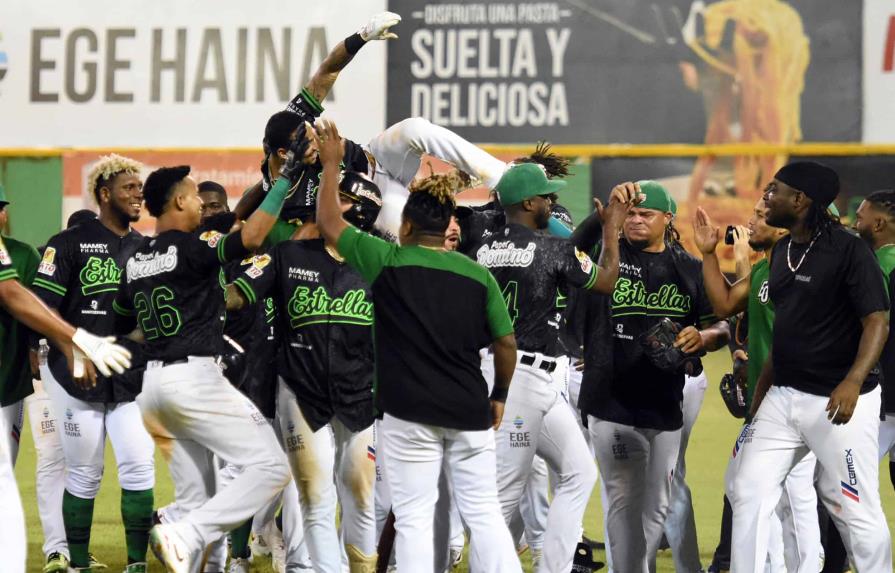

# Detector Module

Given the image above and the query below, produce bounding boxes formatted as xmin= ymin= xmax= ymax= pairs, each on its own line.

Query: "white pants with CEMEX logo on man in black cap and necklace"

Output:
xmin=731 ymin=386 xmax=892 ymax=572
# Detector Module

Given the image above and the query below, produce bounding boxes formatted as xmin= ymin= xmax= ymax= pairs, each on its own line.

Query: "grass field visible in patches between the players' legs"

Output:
xmin=14 ymin=352 xmax=895 ymax=573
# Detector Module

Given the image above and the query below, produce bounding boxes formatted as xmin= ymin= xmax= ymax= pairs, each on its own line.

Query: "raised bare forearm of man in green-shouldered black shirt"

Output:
xmin=309 ymin=120 xmax=348 ymax=244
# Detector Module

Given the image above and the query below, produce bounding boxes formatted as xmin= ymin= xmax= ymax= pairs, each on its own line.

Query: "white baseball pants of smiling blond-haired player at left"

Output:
xmin=40 ymin=366 xmax=155 ymax=499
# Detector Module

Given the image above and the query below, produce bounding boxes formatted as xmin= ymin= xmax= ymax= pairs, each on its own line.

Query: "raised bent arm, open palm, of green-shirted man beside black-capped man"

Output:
xmin=693 ymin=207 xmax=749 ymax=318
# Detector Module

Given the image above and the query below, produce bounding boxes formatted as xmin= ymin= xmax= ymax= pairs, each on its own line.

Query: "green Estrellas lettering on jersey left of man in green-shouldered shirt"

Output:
xmin=288 ymin=286 xmax=373 ymax=329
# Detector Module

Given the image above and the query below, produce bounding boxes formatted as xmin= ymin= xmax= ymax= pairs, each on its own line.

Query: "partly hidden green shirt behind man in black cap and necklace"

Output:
xmin=746 ymin=258 xmax=774 ymax=408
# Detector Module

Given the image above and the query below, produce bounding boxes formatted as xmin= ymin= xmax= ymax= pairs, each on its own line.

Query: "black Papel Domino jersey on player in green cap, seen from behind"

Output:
xmin=475 ymin=223 xmax=597 ymax=356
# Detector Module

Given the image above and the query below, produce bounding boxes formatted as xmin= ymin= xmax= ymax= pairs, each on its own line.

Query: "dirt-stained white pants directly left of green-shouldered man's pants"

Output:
xmin=277 ymin=380 xmax=377 ymax=573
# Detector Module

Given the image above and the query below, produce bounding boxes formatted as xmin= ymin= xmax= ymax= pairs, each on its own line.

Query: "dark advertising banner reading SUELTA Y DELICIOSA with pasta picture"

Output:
xmin=387 ymin=0 xmax=862 ymax=149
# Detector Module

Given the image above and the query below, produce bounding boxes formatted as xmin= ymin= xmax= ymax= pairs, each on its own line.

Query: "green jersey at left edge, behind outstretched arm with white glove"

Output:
xmin=0 ymin=237 xmax=40 ymax=406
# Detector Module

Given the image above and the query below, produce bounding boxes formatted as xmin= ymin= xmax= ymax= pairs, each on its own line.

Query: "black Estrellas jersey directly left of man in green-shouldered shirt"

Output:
xmin=234 ymin=239 xmax=374 ymax=431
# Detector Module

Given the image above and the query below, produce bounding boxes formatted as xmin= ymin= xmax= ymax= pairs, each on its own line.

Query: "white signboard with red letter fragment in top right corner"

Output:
xmin=864 ymin=0 xmax=895 ymax=143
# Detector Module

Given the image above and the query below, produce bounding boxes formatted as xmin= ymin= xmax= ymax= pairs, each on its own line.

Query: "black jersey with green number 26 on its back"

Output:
xmin=114 ymin=231 xmax=248 ymax=362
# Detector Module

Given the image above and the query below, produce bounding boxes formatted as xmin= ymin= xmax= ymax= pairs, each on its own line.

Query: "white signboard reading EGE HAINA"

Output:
xmin=0 ymin=0 xmax=388 ymax=147
